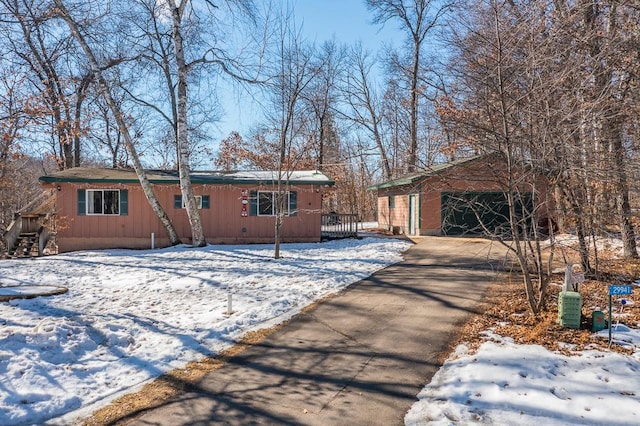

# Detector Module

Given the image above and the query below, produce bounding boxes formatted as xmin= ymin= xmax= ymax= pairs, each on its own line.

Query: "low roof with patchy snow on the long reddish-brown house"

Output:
xmin=40 ymin=167 xmax=335 ymax=185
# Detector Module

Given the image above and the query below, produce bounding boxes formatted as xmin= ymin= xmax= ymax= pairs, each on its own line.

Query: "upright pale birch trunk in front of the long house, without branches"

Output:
xmin=171 ymin=0 xmax=207 ymax=247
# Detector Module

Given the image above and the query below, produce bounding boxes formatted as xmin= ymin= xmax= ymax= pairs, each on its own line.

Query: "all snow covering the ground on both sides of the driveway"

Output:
xmin=5 ymin=233 xmax=640 ymax=426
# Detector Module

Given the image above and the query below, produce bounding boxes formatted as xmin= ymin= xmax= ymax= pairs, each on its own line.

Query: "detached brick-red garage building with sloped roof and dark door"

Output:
xmin=368 ymin=155 xmax=548 ymax=235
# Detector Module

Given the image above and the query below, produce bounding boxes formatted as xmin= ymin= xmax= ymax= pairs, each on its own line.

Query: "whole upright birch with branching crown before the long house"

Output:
xmin=130 ymin=0 xmax=256 ymax=246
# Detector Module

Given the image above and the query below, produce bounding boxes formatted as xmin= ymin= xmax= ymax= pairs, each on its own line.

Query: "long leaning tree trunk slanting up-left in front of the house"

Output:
xmin=54 ymin=0 xmax=180 ymax=245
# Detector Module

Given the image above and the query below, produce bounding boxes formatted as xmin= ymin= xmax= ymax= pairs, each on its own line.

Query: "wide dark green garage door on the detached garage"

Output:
xmin=441 ymin=192 xmax=533 ymax=237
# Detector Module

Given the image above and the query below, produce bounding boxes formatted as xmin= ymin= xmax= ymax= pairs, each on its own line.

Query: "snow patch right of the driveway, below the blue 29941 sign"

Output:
xmin=405 ymin=245 xmax=640 ymax=426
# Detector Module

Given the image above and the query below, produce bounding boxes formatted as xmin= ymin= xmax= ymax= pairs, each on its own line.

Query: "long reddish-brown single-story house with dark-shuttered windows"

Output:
xmin=40 ymin=168 xmax=334 ymax=252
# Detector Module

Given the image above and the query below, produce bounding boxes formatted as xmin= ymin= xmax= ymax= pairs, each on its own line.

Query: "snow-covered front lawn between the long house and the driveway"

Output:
xmin=0 ymin=238 xmax=409 ymax=425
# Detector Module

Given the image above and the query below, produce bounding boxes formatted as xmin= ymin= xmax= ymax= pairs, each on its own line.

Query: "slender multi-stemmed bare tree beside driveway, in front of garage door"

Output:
xmin=441 ymin=0 xmax=561 ymax=315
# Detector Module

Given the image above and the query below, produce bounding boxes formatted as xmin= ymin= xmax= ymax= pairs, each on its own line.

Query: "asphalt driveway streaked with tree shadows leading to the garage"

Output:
xmin=127 ymin=237 xmax=505 ymax=425
